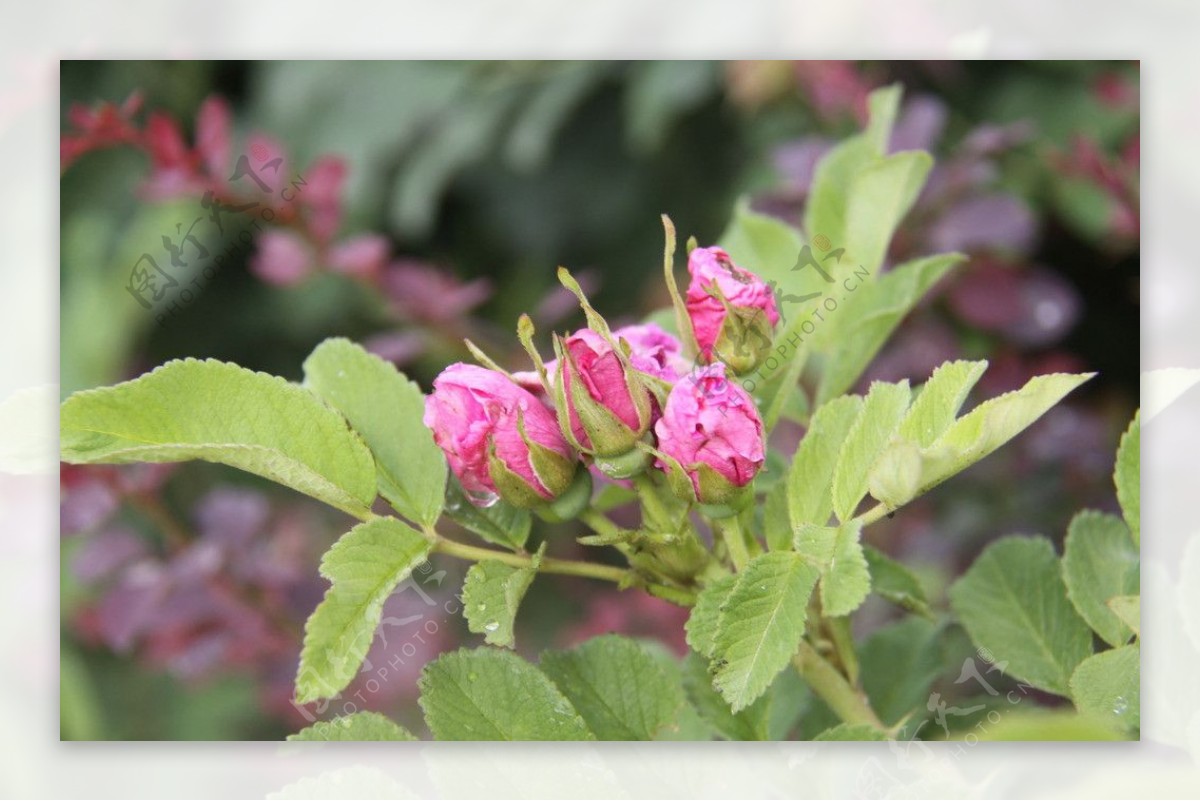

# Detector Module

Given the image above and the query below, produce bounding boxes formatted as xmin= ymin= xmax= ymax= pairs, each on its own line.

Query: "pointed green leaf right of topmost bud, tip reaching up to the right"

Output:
xmin=816 ymin=253 xmax=966 ymax=404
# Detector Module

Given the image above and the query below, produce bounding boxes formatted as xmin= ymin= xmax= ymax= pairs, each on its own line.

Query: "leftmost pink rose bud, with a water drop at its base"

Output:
xmin=425 ymin=363 xmax=578 ymax=507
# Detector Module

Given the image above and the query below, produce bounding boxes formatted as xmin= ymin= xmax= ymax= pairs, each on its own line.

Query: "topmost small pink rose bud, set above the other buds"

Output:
xmin=688 ymin=247 xmax=779 ymax=374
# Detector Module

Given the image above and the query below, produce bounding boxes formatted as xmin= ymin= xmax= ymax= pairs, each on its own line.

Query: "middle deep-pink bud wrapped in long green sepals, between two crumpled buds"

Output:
xmin=554 ymin=329 xmax=650 ymax=477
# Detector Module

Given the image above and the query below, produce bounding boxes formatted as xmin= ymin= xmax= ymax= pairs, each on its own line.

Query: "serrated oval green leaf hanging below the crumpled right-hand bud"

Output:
xmin=713 ymin=550 xmax=818 ymax=712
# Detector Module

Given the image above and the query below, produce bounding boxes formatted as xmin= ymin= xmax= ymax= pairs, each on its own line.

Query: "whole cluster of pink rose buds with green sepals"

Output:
xmin=425 ymin=241 xmax=779 ymax=519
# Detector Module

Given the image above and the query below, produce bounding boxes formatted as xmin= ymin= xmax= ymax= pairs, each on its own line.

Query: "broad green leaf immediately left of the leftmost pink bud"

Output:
xmin=304 ymin=339 xmax=446 ymax=525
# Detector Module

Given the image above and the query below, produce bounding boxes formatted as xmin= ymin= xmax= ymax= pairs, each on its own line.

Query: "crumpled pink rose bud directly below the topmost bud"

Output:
xmin=654 ymin=362 xmax=763 ymax=504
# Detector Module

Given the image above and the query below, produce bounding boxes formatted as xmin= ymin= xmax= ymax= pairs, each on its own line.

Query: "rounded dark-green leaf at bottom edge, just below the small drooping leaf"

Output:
xmin=418 ymin=648 xmax=595 ymax=741
